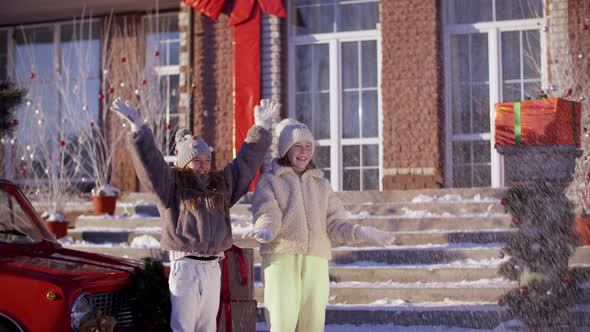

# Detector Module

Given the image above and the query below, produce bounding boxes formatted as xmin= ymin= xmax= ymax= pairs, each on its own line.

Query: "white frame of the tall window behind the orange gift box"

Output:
xmin=443 ymin=9 xmax=548 ymax=187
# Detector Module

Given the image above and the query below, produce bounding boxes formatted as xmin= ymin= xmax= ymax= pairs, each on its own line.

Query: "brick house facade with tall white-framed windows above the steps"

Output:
xmin=0 ymin=0 xmax=590 ymax=191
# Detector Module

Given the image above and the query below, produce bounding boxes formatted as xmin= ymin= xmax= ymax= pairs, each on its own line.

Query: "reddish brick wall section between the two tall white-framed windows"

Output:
xmin=381 ymin=0 xmax=444 ymax=190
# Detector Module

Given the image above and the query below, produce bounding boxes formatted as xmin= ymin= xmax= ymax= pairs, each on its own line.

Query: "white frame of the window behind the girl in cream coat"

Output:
xmin=288 ymin=10 xmax=383 ymax=191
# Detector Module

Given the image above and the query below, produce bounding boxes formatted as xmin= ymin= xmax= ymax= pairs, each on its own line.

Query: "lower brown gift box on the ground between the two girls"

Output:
xmin=217 ymin=300 xmax=258 ymax=332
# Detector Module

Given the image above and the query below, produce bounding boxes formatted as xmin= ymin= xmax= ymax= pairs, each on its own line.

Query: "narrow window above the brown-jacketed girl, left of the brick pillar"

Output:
xmin=144 ymin=13 xmax=180 ymax=156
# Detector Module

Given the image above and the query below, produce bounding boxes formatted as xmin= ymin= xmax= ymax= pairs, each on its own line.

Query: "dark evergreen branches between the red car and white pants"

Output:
xmin=128 ymin=258 xmax=171 ymax=332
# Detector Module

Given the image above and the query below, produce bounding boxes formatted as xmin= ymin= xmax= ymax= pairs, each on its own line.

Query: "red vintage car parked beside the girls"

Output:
xmin=0 ymin=179 xmax=141 ymax=332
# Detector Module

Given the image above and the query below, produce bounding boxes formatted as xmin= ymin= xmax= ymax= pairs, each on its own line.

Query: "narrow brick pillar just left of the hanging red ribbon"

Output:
xmin=192 ymin=8 xmax=234 ymax=168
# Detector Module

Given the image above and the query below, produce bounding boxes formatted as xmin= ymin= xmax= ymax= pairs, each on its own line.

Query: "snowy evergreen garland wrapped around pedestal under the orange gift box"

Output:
xmin=498 ymin=181 xmax=582 ymax=326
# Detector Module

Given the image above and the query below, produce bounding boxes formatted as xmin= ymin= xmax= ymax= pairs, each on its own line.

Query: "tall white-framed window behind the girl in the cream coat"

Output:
xmin=289 ymin=0 xmax=381 ymax=190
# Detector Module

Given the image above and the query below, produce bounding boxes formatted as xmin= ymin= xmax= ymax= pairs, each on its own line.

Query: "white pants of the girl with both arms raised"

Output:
xmin=168 ymin=258 xmax=221 ymax=332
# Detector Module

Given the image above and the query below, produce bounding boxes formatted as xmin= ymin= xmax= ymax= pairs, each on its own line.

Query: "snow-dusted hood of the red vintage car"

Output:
xmin=0 ymin=241 xmax=141 ymax=287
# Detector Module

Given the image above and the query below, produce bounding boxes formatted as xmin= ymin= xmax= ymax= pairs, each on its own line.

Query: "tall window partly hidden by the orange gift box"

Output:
xmin=443 ymin=0 xmax=546 ymax=187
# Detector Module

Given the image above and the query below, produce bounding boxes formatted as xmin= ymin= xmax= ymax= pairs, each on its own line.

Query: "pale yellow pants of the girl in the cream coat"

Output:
xmin=262 ymin=254 xmax=330 ymax=332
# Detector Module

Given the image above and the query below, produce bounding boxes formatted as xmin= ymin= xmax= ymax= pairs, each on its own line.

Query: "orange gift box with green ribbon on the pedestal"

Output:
xmin=494 ymin=98 xmax=582 ymax=147
